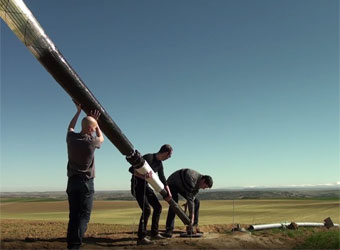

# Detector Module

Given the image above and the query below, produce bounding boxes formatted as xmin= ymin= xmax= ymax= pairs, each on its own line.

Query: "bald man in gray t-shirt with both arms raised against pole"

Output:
xmin=66 ymin=102 xmax=104 ymax=249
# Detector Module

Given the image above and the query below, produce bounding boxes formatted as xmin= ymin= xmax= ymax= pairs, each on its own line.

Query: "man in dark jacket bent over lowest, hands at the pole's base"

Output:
xmin=163 ymin=168 xmax=213 ymax=238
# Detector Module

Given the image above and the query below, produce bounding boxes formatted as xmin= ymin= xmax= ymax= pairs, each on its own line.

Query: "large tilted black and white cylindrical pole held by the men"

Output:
xmin=0 ymin=0 xmax=190 ymax=224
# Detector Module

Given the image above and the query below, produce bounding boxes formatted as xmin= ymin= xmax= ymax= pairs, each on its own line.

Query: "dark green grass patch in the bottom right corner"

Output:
xmin=293 ymin=231 xmax=340 ymax=249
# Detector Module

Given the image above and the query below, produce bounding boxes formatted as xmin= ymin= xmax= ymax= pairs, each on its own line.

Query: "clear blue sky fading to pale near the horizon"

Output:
xmin=1 ymin=0 xmax=340 ymax=191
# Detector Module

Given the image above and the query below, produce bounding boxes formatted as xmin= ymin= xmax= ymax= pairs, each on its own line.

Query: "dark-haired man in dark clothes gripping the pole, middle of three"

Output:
xmin=129 ymin=144 xmax=172 ymax=245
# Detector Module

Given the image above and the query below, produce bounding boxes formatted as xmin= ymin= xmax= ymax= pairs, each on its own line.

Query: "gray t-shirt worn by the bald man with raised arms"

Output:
xmin=66 ymin=132 xmax=101 ymax=179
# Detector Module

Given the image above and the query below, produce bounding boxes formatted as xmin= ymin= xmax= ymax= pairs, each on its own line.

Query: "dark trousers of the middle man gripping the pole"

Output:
xmin=132 ymin=181 xmax=162 ymax=239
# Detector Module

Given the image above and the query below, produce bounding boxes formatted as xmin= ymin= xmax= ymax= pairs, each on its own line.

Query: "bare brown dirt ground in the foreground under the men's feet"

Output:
xmin=1 ymin=220 xmax=338 ymax=250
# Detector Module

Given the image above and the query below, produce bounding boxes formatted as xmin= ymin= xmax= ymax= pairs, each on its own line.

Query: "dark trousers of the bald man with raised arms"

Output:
xmin=66 ymin=176 xmax=94 ymax=249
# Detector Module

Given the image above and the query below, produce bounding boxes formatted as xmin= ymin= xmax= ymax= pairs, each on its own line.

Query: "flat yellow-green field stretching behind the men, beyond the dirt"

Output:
xmin=0 ymin=199 xmax=340 ymax=225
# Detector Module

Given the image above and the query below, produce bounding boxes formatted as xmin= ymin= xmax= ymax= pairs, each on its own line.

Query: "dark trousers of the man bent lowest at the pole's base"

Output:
xmin=166 ymin=185 xmax=200 ymax=232
